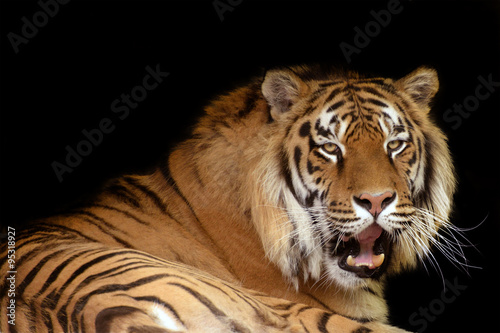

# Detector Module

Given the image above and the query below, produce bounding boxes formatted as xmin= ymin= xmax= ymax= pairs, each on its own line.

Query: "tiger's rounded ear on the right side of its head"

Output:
xmin=396 ymin=67 xmax=439 ymax=111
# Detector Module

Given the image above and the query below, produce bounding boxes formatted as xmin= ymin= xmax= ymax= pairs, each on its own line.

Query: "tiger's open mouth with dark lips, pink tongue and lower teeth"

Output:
xmin=336 ymin=224 xmax=391 ymax=278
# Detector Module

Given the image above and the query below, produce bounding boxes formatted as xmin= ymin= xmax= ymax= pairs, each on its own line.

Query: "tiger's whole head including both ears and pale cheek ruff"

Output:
xmin=250 ymin=67 xmax=455 ymax=289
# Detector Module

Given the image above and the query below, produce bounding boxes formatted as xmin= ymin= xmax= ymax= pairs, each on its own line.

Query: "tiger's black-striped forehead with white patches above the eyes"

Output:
xmin=296 ymin=79 xmax=413 ymax=149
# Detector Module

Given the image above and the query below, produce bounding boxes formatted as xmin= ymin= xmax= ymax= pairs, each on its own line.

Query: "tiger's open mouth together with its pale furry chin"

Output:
xmin=325 ymin=231 xmax=393 ymax=289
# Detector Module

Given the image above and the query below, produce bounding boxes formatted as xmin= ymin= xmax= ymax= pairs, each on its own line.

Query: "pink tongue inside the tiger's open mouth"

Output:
xmin=347 ymin=223 xmax=384 ymax=269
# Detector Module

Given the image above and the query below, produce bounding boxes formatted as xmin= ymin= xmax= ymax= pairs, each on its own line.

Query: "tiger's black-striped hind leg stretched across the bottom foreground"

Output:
xmin=0 ymin=242 xmax=408 ymax=333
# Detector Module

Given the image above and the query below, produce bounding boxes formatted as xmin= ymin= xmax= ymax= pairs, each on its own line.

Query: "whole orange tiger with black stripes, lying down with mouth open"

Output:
xmin=0 ymin=65 xmax=459 ymax=333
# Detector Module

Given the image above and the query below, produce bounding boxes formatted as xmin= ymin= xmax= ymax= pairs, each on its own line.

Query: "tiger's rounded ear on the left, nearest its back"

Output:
xmin=262 ymin=69 xmax=307 ymax=119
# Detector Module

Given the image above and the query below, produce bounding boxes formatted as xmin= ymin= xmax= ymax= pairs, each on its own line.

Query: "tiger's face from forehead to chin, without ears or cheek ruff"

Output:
xmin=286 ymin=89 xmax=423 ymax=284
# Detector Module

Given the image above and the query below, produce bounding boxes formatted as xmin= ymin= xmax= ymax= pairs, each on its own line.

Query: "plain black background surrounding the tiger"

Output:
xmin=0 ymin=0 xmax=500 ymax=332
